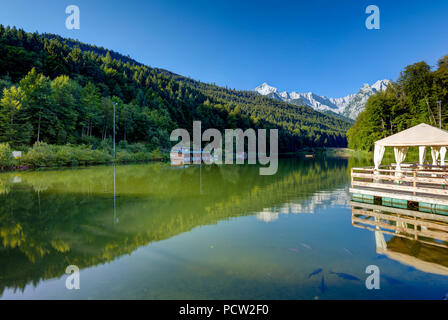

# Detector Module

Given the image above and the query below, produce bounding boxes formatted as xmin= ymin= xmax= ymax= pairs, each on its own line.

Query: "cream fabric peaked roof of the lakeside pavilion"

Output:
xmin=375 ymin=123 xmax=448 ymax=147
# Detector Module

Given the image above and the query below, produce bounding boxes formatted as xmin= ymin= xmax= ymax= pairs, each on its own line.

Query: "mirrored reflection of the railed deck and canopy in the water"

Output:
xmin=351 ymin=202 xmax=448 ymax=276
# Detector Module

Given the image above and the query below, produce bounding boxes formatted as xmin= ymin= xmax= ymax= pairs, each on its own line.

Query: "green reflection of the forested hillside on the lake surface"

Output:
xmin=0 ymin=159 xmax=348 ymax=294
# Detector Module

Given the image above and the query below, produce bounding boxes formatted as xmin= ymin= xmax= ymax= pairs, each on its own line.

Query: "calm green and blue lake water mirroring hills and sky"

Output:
xmin=0 ymin=157 xmax=448 ymax=300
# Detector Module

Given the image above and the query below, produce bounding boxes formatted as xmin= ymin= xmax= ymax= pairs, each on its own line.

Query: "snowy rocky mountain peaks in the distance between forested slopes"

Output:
xmin=254 ymin=80 xmax=390 ymax=119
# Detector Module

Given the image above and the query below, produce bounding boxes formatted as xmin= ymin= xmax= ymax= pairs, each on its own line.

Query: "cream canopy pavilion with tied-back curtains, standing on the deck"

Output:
xmin=373 ymin=123 xmax=448 ymax=171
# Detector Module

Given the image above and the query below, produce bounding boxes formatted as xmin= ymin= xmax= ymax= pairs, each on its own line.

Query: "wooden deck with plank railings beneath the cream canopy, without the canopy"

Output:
xmin=350 ymin=164 xmax=448 ymax=210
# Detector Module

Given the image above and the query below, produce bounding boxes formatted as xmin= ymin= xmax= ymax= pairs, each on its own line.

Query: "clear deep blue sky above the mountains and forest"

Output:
xmin=0 ymin=0 xmax=448 ymax=97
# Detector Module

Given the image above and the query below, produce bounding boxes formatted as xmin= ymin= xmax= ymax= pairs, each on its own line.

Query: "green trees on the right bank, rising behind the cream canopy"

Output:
xmin=347 ymin=55 xmax=448 ymax=150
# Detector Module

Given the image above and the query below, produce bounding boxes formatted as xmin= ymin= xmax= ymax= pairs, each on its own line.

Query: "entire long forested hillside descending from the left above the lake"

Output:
xmin=0 ymin=25 xmax=350 ymax=151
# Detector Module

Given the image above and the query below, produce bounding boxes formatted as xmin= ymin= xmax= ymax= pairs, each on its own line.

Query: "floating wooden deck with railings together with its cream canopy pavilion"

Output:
xmin=350 ymin=124 xmax=448 ymax=215
